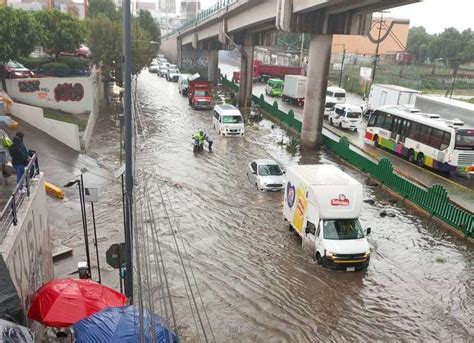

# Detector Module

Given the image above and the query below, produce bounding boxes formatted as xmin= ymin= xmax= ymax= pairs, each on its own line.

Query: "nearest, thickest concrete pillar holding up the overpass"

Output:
xmin=301 ymin=34 xmax=332 ymax=149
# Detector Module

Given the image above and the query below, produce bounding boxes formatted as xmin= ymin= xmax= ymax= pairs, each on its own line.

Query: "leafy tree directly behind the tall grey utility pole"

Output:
xmin=87 ymin=14 xmax=156 ymax=85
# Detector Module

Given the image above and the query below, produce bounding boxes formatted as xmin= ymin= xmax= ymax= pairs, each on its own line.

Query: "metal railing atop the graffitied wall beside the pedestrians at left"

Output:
xmin=0 ymin=154 xmax=39 ymax=244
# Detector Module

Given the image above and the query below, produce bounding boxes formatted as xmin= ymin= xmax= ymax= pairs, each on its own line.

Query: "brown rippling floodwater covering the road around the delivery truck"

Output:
xmin=137 ymin=71 xmax=474 ymax=342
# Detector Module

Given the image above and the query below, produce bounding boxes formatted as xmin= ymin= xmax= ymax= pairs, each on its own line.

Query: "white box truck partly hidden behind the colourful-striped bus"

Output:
xmin=366 ymin=84 xmax=421 ymax=116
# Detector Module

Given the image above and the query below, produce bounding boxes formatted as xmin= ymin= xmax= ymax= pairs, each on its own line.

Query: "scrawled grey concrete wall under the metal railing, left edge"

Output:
xmin=0 ymin=174 xmax=53 ymax=330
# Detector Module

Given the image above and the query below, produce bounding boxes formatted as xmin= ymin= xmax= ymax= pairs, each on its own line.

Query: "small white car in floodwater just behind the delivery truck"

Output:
xmin=247 ymin=160 xmax=285 ymax=191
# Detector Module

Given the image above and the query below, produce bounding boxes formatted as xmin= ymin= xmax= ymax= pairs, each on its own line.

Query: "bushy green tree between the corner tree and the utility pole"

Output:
xmin=35 ymin=9 xmax=86 ymax=58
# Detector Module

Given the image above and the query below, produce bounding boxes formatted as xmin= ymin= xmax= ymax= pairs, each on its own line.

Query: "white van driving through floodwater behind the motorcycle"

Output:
xmin=212 ymin=104 xmax=245 ymax=136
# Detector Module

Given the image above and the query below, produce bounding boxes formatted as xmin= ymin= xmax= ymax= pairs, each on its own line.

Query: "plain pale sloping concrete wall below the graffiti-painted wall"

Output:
xmin=9 ymin=103 xmax=81 ymax=151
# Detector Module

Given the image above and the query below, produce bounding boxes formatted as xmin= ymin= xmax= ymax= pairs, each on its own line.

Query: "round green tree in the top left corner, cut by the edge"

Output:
xmin=0 ymin=6 xmax=41 ymax=89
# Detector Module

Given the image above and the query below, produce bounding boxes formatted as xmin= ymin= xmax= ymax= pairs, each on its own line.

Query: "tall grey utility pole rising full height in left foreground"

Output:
xmin=122 ymin=0 xmax=133 ymax=304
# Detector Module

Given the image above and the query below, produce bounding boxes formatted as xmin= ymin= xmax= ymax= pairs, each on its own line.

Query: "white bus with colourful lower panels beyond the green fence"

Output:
xmin=364 ymin=105 xmax=474 ymax=174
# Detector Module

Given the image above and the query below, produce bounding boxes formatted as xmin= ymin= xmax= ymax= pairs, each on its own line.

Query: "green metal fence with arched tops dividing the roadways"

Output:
xmin=222 ymin=77 xmax=474 ymax=238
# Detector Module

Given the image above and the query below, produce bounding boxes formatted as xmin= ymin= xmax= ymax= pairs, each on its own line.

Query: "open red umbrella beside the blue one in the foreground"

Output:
xmin=28 ymin=278 xmax=127 ymax=327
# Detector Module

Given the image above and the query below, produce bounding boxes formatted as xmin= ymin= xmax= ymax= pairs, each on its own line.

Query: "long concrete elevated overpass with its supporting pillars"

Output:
xmin=161 ymin=0 xmax=420 ymax=147
